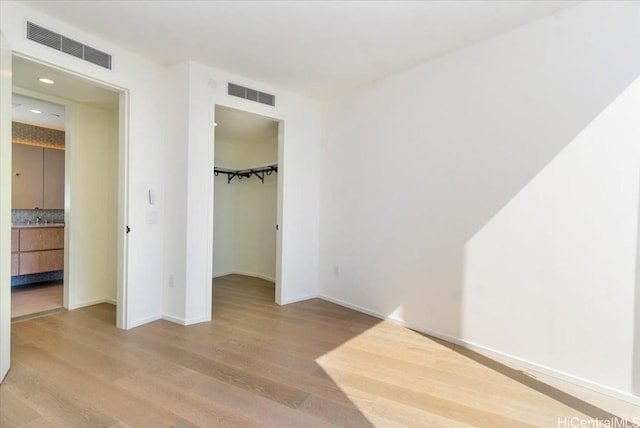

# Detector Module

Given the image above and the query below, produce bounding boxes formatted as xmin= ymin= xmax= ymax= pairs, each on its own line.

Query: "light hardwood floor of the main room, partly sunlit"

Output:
xmin=0 ymin=275 xmax=640 ymax=428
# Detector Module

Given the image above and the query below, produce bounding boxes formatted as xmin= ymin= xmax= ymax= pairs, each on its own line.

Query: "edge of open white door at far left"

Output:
xmin=0 ymin=32 xmax=11 ymax=382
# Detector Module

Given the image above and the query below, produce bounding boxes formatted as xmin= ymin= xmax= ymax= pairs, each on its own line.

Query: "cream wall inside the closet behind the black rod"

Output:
xmin=213 ymin=132 xmax=278 ymax=281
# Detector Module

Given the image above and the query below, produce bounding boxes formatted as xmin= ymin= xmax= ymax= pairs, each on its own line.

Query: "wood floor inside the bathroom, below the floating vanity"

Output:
xmin=11 ymin=281 xmax=63 ymax=321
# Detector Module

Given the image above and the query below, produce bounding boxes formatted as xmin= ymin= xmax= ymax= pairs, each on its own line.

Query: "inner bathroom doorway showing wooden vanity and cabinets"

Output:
xmin=11 ymin=93 xmax=66 ymax=321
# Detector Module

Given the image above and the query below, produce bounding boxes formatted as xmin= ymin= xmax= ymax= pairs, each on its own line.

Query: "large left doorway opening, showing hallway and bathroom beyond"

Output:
xmin=11 ymin=56 xmax=124 ymax=321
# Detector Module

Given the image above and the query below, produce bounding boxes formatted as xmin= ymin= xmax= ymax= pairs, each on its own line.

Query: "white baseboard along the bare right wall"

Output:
xmin=318 ymin=294 xmax=640 ymax=405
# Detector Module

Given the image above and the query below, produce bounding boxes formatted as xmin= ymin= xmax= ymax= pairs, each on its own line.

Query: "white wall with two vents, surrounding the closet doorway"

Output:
xmin=0 ymin=0 xmax=321 ymax=328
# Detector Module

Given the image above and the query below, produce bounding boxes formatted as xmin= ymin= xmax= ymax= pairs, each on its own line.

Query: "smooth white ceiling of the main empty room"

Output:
xmin=23 ymin=0 xmax=579 ymax=98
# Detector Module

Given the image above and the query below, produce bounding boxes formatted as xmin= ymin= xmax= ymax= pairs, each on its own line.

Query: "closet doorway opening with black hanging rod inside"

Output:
xmin=213 ymin=106 xmax=280 ymax=302
